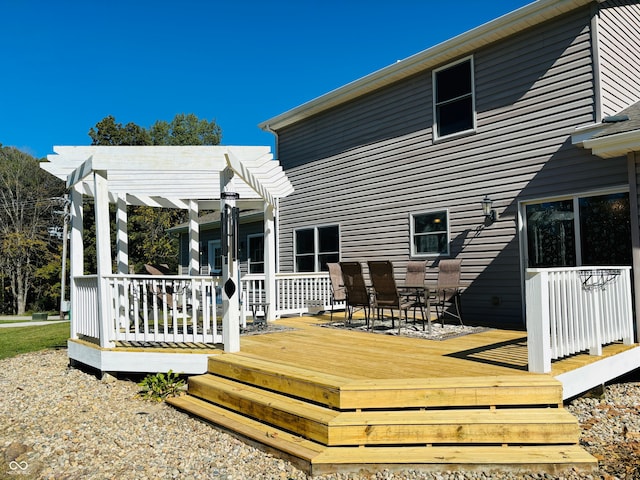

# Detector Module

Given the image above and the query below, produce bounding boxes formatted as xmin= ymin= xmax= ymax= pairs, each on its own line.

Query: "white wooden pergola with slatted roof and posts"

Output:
xmin=41 ymin=146 xmax=293 ymax=351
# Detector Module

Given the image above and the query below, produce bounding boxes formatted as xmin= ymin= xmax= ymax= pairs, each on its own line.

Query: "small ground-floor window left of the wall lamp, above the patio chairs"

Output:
xmin=410 ymin=210 xmax=449 ymax=257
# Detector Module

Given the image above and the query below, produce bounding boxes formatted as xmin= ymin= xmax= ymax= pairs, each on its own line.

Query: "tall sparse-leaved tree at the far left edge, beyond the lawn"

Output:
xmin=0 ymin=146 xmax=64 ymax=315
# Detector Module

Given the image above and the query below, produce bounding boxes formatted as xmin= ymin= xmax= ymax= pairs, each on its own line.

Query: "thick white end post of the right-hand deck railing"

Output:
xmin=525 ymin=270 xmax=551 ymax=373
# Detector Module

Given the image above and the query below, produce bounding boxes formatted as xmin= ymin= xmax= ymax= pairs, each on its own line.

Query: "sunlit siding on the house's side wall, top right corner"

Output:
xmin=598 ymin=0 xmax=640 ymax=116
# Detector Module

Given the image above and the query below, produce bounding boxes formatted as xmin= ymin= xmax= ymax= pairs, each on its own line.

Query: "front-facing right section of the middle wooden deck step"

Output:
xmin=328 ymin=408 xmax=580 ymax=445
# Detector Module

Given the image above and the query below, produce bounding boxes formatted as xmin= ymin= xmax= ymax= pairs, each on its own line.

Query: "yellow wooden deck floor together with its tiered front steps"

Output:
xmin=164 ymin=316 xmax=621 ymax=474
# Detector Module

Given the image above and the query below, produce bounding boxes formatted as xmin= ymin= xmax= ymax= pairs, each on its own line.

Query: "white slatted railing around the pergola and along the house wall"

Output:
xmin=71 ymin=273 xmax=344 ymax=344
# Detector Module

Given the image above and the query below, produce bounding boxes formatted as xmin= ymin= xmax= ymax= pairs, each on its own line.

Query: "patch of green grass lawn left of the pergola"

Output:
xmin=0 ymin=322 xmax=69 ymax=359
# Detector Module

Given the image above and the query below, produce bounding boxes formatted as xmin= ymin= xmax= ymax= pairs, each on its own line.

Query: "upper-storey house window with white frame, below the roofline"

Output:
xmin=433 ymin=58 xmax=475 ymax=138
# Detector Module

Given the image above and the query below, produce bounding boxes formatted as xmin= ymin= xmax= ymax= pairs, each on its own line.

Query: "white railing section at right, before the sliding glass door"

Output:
xmin=526 ymin=267 xmax=633 ymax=373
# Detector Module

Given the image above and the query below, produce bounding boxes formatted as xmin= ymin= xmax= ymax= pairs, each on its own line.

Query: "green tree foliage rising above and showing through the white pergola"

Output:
xmin=85 ymin=113 xmax=222 ymax=272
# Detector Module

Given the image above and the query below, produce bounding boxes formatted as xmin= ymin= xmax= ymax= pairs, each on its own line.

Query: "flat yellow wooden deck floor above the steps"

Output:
xmin=240 ymin=319 xmax=526 ymax=379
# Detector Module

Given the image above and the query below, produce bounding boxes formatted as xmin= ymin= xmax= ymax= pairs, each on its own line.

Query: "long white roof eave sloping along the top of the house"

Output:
xmin=258 ymin=0 xmax=595 ymax=132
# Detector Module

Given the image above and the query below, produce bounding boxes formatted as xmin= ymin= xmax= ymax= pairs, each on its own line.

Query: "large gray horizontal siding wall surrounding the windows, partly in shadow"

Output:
xmin=278 ymin=9 xmax=626 ymax=323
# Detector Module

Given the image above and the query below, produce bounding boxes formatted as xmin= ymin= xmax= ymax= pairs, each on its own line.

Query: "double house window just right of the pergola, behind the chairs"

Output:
xmin=295 ymin=225 xmax=340 ymax=272
